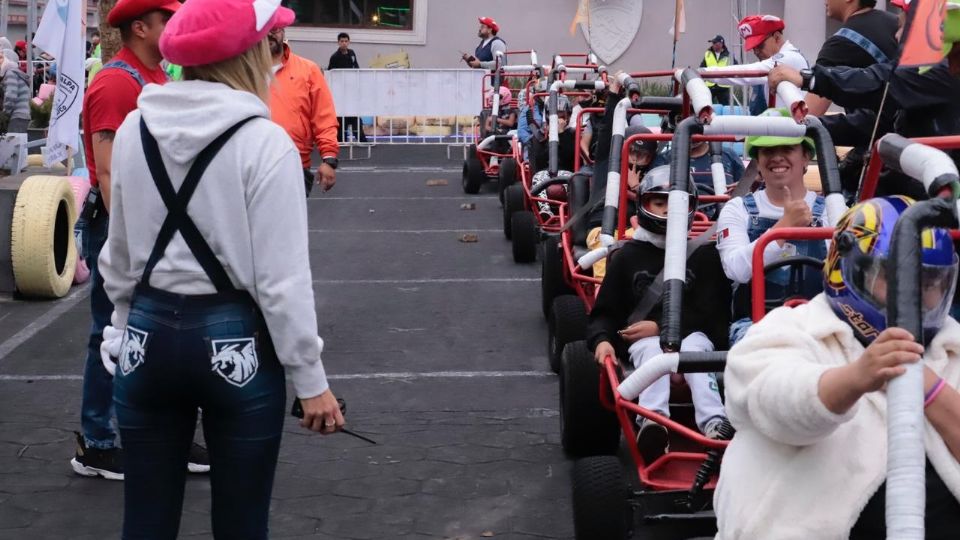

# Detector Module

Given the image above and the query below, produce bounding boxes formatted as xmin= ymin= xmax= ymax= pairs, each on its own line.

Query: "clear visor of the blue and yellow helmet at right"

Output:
xmin=843 ymin=254 xmax=958 ymax=329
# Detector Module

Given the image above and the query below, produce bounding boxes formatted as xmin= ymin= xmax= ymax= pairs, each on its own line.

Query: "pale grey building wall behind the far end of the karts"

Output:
xmin=291 ymin=0 xmax=825 ymax=70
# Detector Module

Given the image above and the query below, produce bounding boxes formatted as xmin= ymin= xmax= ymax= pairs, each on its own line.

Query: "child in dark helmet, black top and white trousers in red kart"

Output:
xmin=588 ymin=166 xmax=730 ymax=463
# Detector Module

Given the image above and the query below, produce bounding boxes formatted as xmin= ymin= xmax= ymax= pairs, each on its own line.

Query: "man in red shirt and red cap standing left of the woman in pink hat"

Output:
xmin=70 ymin=0 xmax=209 ymax=480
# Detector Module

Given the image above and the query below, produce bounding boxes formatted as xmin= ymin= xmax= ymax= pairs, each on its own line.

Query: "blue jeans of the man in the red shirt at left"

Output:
xmin=78 ymin=210 xmax=117 ymax=449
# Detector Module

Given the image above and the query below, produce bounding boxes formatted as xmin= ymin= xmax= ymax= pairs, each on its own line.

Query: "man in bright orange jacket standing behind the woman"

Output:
xmin=267 ymin=24 xmax=340 ymax=196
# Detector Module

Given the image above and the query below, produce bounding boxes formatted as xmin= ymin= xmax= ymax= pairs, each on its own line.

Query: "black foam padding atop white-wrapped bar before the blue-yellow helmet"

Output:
xmin=885 ymin=198 xmax=957 ymax=342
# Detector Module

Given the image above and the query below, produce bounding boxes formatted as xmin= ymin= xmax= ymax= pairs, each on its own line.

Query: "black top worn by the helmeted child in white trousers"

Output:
xmin=587 ymin=240 xmax=732 ymax=350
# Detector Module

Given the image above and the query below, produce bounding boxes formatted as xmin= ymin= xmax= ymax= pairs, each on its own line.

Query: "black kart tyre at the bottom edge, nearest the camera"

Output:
xmin=573 ymin=456 xmax=631 ymax=540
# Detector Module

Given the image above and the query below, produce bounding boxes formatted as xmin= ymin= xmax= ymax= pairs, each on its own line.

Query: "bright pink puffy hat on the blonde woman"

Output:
xmin=160 ymin=0 xmax=294 ymax=66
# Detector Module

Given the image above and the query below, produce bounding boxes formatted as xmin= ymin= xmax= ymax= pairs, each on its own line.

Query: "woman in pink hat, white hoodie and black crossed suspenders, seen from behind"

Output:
xmin=100 ymin=0 xmax=344 ymax=539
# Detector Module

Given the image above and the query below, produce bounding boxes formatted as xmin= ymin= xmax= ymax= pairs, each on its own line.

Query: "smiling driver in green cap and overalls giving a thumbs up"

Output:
xmin=717 ymin=109 xmax=827 ymax=344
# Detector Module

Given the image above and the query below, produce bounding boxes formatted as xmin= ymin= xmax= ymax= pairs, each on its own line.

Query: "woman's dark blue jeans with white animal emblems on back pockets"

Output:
xmin=114 ymin=289 xmax=286 ymax=540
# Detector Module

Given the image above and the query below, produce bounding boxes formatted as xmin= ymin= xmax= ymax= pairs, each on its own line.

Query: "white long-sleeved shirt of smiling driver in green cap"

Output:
xmin=717 ymin=190 xmax=817 ymax=283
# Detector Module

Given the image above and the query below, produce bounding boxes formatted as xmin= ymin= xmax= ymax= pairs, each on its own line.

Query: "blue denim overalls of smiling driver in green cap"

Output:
xmin=730 ymin=193 xmax=827 ymax=347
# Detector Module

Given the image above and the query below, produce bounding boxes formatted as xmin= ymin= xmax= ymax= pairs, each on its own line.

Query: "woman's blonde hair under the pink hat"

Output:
xmin=183 ymin=38 xmax=273 ymax=103
